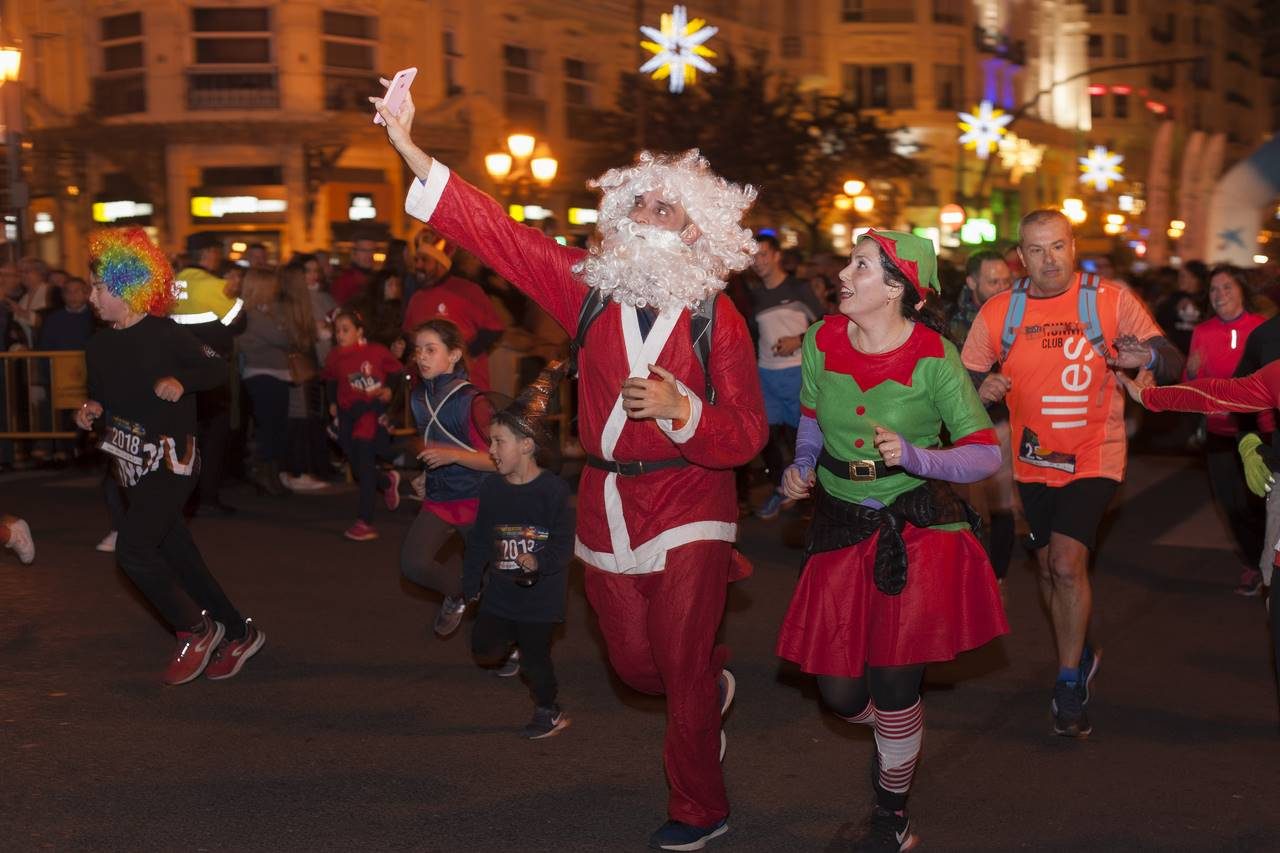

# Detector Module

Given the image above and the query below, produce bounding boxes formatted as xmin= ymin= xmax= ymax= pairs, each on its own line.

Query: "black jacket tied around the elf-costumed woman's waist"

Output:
xmin=805 ymin=480 xmax=982 ymax=596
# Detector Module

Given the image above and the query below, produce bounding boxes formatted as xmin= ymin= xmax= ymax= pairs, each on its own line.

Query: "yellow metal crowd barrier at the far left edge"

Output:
xmin=0 ymin=350 xmax=88 ymax=439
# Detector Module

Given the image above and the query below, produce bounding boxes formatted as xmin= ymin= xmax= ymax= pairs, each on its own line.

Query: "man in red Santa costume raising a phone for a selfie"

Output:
xmin=370 ymin=84 xmax=768 ymax=850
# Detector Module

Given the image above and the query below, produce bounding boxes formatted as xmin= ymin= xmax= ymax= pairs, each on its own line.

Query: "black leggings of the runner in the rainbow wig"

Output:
xmin=115 ymin=467 xmax=244 ymax=639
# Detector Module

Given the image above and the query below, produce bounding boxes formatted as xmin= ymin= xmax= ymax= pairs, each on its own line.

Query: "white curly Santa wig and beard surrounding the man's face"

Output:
xmin=573 ymin=149 xmax=756 ymax=307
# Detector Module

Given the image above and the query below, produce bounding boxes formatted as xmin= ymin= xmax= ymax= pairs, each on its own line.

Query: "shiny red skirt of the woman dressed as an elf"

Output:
xmin=777 ymin=524 xmax=1009 ymax=678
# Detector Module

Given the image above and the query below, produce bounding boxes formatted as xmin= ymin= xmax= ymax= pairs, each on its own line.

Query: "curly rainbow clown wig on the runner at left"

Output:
xmin=88 ymin=228 xmax=177 ymax=316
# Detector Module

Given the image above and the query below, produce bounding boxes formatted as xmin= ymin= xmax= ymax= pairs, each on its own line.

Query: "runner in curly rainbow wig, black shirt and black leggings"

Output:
xmin=76 ymin=228 xmax=266 ymax=684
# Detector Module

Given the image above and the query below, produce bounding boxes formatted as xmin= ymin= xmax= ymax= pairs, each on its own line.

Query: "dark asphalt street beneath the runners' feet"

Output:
xmin=0 ymin=456 xmax=1280 ymax=852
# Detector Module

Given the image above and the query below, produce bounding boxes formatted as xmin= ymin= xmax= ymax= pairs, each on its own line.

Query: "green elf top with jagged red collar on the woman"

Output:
xmin=800 ymin=316 xmax=992 ymax=505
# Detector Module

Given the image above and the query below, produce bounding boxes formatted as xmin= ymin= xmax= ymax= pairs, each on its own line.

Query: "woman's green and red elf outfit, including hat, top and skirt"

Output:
xmin=777 ymin=231 xmax=1009 ymax=678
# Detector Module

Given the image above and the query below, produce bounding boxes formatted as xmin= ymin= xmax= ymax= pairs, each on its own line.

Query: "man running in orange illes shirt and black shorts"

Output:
xmin=961 ymin=210 xmax=1183 ymax=738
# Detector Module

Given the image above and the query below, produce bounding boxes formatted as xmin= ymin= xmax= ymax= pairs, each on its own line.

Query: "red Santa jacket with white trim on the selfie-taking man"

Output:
xmin=404 ymin=161 xmax=768 ymax=574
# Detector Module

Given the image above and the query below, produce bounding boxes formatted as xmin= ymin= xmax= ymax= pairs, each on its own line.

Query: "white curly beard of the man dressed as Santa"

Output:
xmin=573 ymin=219 xmax=724 ymax=310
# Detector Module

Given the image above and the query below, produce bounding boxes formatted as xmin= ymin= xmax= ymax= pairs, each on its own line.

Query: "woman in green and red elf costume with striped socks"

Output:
xmin=777 ymin=229 xmax=1009 ymax=850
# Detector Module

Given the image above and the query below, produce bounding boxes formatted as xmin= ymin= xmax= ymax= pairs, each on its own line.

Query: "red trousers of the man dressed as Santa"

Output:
xmin=586 ymin=540 xmax=733 ymax=826
